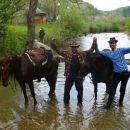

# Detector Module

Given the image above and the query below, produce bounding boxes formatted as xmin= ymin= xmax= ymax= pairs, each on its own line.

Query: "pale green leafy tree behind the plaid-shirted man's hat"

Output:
xmin=58 ymin=1 xmax=85 ymax=38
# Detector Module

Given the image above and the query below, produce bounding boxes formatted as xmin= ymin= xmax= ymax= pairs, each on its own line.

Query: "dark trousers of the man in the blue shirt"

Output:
xmin=107 ymin=71 xmax=129 ymax=107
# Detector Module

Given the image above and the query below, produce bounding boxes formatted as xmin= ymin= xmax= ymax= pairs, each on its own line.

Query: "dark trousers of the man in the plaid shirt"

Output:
xmin=64 ymin=76 xmax=83 ymax=104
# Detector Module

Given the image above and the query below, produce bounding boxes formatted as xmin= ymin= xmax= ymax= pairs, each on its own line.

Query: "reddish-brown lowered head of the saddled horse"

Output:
xmin=0 ymin=57 xmax=11 ymax=87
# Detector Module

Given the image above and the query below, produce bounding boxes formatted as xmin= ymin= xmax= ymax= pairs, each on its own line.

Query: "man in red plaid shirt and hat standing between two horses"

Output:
xmin=51 ymin=39 xmax=94 ymax=105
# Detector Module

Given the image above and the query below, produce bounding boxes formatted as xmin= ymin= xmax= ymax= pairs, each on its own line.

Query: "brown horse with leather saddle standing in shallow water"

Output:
xmin=1 ymin=47 xmax=58 ymax=105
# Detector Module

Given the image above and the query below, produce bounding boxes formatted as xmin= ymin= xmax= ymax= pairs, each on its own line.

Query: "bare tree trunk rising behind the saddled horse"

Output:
xmin=25 ymin=0 xmax=38 ymax=49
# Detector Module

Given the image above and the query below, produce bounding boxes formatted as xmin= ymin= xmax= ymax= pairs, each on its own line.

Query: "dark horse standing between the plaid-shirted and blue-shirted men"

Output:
xmin=79 ymin=53 xmax=113 ymax=100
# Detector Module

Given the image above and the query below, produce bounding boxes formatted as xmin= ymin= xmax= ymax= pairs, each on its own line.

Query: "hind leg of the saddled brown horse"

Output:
xmin=45 ymin=75 xmax=57 ymax=97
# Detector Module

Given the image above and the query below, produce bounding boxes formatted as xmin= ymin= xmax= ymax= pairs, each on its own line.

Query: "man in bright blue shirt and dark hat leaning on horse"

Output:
xmin=93 ymin=37 xmax=130 ymax=108
